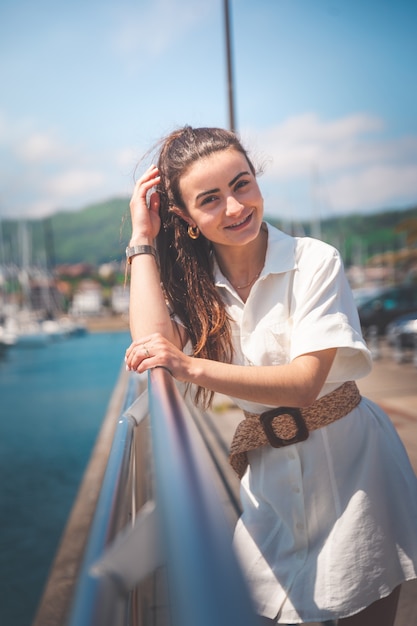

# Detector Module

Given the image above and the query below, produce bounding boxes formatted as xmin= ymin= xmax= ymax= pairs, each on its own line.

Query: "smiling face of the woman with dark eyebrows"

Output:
xmin=176 ymin=149 xmax=263 ymax=245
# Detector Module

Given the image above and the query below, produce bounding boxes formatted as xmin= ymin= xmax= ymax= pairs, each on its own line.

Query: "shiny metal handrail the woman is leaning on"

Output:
xmin=68 ymin=368 xmax=258 ymax=626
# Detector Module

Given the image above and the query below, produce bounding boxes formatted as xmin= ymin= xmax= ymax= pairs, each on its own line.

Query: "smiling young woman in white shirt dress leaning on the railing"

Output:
xmin=126 ymin=127 xmax=417 ymax=626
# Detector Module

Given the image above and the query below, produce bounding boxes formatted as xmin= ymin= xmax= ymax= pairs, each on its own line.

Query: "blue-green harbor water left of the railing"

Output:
xmin=0 ymin=332 xmax=129 ymax=626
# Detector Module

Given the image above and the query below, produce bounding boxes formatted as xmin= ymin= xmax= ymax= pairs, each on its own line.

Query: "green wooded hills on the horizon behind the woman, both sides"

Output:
xmin=0 ymin=198 xmax=417 ymax=266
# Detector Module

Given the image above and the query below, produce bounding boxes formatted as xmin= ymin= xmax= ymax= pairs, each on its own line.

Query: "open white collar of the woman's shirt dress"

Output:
xmin=213 ymin=222 xmax=297 ymax=287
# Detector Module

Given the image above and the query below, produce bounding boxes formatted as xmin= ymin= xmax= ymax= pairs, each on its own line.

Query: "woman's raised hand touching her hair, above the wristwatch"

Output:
xmin=130 ymin=165 xmax=161 ymax=245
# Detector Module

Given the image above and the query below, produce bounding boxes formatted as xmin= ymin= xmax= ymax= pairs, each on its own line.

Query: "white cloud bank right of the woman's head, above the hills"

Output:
xmin=245 ymin=114 xmax=417 ymax=213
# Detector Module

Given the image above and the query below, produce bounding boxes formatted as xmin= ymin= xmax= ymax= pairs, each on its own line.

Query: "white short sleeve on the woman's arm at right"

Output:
xmin=290 ymin=238 xmax=371 ymax=382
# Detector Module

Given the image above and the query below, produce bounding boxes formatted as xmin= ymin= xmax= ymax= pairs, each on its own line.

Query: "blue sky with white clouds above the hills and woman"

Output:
xmin=0 ymin=0 xmax=417 ymax=220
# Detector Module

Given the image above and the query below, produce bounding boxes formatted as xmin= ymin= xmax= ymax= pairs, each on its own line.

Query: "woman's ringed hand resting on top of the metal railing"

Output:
xmin=125 ymin=333 xmax=193 ymax=382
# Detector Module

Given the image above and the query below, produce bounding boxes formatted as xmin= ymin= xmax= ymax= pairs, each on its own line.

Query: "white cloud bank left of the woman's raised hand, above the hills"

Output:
xmin=0 ymin=112 xmax=133 ymax=217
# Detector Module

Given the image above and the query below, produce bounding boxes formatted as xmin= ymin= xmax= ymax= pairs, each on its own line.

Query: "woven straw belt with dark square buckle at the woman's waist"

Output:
xmin=229 ymin=381 xmax=361 ymax=478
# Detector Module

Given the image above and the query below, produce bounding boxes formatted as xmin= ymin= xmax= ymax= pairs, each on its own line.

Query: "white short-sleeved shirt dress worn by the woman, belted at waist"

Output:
xmin=215 ymin=225 xmax=417 ymax=624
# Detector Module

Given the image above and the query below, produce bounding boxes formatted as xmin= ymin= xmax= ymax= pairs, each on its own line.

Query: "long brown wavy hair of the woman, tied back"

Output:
xmin=147 ymin=126 xmax=255 ymax=406
